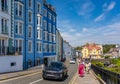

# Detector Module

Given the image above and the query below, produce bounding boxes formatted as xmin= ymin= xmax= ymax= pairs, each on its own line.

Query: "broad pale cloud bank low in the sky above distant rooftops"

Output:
xmin=61 ymin=21 xmax=120 ymax=47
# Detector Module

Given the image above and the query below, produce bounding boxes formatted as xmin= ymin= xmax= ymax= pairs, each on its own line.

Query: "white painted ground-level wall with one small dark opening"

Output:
xmin=0 ymin=55 xmax=23 ymax=73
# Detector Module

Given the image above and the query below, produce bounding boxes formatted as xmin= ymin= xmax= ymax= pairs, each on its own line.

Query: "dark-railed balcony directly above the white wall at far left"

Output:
xmin=0 ymin=47 xmax=22 ymax=56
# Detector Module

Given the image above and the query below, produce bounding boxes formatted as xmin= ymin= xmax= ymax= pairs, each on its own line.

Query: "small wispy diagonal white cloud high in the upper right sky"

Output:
xmin=94 ymin=2 xmax=116 ymax=22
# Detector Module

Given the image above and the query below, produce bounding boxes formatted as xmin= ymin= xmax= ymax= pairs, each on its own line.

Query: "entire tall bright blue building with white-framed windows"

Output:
xmin=14 ymin=0 xmax=56 ymax=69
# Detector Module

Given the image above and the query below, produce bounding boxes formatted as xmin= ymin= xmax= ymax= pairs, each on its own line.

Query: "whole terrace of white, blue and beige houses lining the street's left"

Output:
xmin=0 ymin=0 xmax=74 ymax=73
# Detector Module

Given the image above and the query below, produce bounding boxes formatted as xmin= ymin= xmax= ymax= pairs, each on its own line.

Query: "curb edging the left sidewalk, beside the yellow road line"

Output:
xmin=0 ymin=70 xmax=42 ymax=81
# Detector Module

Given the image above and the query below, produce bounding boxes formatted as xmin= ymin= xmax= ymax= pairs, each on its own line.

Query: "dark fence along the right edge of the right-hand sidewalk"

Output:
xmin=91 ymin=65 xmax=120 ymax=84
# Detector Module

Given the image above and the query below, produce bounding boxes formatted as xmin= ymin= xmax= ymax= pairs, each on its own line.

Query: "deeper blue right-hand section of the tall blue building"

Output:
xmin=43 ymin=0 xmax=57 ymax=65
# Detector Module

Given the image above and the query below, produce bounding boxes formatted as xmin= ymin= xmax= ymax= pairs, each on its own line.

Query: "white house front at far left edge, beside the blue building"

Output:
xmin=0 ymin=0 xmax=11 ymax=55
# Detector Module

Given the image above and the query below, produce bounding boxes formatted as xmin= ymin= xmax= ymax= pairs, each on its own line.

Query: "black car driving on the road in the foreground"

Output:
xmin=42 ymin=62 xmax=68 ymax=80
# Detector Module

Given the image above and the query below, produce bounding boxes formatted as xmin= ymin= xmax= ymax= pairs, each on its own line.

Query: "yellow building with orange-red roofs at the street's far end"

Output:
xmin=82 ymin=43 xmax=103 ymax=58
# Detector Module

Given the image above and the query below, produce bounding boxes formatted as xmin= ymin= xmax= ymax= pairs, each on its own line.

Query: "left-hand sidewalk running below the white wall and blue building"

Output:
xmin=0 ymin=66 xmax=42 ymax=81
